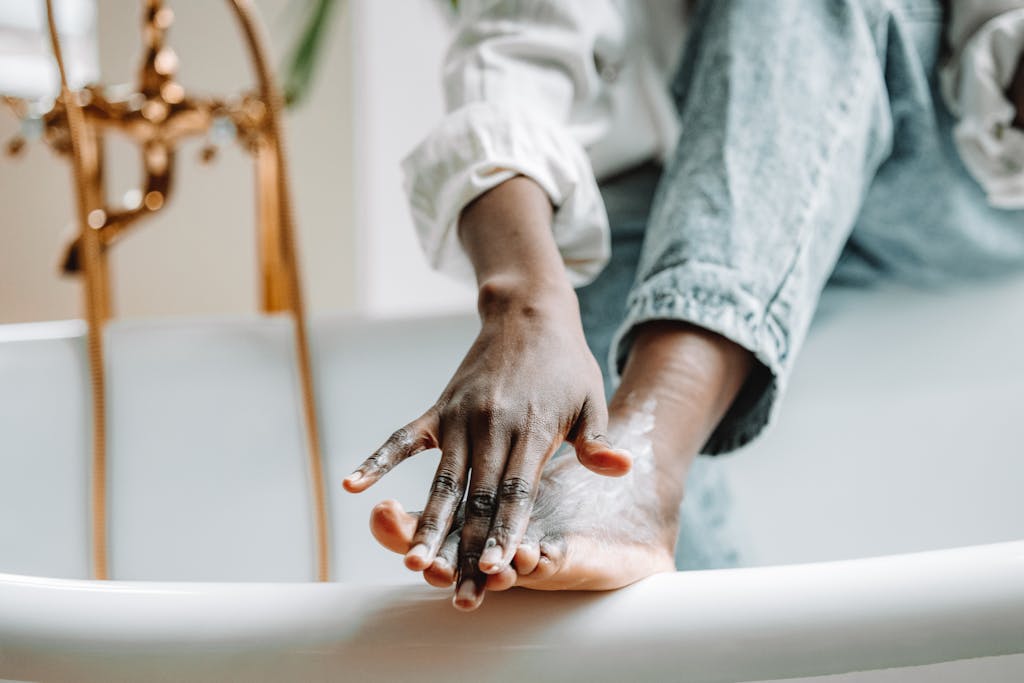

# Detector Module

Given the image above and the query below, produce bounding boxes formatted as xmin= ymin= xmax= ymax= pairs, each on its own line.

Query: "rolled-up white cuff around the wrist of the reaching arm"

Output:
xmin=402 ymin=102 xmax=611 ymax=287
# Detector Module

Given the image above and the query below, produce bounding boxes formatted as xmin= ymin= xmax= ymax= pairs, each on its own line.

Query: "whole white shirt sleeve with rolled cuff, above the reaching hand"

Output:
xmin=402 ymin=0 xmax=628 ymax=286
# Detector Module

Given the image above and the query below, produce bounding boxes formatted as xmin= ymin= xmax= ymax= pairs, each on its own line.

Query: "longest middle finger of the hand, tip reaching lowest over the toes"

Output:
xmin=453 ymin=426 xmax=509 ymax=610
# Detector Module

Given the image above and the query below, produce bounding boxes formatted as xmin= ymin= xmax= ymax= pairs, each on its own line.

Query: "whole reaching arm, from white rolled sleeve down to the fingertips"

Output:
xmin=345 ymin=0 xmax=630 ymax=608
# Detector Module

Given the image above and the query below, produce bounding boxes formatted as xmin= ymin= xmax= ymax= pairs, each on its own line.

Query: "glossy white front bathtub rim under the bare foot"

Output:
xmin=0 ymin=541 xmax=1024 ymax=681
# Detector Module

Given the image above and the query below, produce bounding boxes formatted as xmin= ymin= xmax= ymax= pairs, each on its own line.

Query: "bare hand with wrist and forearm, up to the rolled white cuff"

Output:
xmin=344 ymin=178 xmax=631 ymax=609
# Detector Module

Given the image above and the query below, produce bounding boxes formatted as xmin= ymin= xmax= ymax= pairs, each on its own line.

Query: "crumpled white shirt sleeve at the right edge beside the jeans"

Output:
xmin=940 ymin=0 xmax=1024 ymax=209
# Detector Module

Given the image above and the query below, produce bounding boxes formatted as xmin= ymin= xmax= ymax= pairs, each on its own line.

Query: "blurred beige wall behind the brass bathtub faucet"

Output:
xmin=0 ymin=0 xmax=355 ymax=323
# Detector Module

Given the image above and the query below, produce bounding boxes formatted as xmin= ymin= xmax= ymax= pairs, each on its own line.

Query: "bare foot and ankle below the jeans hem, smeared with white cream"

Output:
xmin=371 ymin=323 xmax=753 ymax=609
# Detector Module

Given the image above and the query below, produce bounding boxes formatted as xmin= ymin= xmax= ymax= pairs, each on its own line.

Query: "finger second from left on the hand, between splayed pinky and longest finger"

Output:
xmin=406 ymin=427 xmax=469 ymax=571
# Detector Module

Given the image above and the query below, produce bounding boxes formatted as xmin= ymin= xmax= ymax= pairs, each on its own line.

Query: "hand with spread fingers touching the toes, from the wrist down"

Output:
xmin=345 ymin=297 xmax=630 ymax=608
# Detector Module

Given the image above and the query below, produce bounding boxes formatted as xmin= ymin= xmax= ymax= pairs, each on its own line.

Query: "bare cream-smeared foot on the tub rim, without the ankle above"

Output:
xmin=371 ymin=405 xmax=679 ymax=609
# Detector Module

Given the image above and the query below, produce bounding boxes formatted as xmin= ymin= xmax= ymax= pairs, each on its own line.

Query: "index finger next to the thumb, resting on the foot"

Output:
xmin=480 ymin=433 xmax=556 ymax=574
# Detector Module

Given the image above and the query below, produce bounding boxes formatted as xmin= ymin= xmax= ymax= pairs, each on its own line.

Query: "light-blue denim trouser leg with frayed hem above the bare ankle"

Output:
xmin=612 ymin=0 xmax=941 ymax=454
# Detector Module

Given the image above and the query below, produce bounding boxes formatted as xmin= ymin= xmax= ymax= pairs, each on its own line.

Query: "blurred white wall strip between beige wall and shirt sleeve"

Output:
xmin=352 ymin=0 xmax=474 ymax=314
